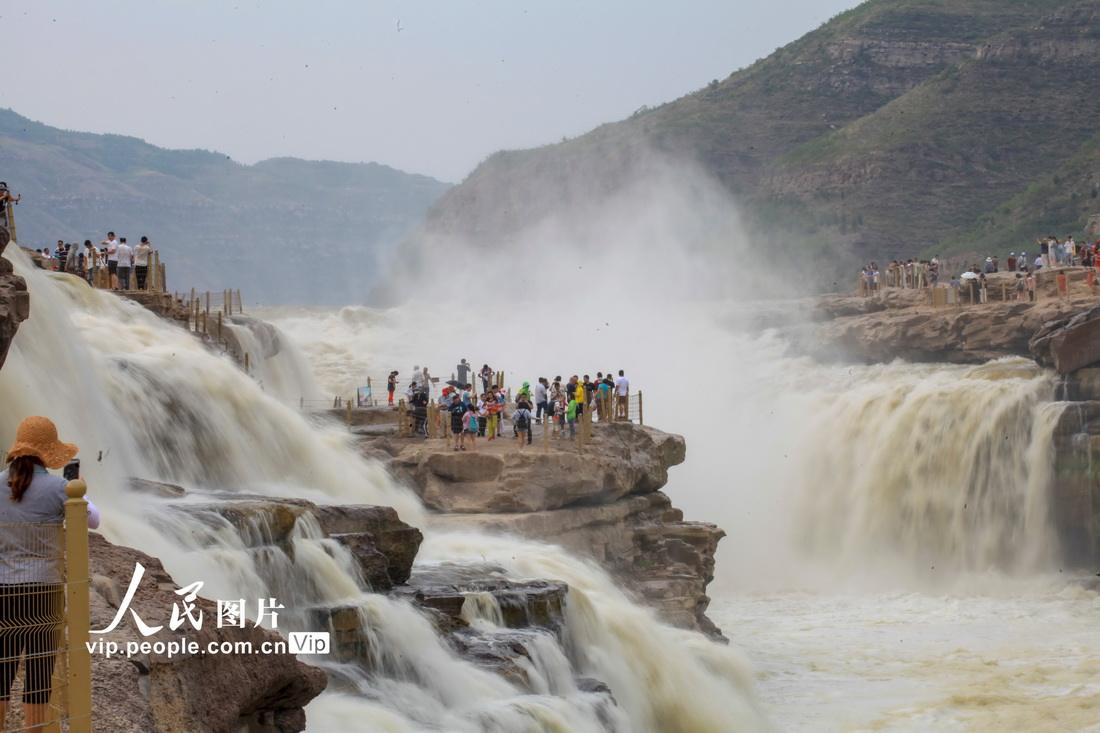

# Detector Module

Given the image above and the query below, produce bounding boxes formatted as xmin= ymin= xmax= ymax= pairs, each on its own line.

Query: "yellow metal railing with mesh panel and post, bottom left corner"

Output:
xmin=0 ymin=480 xmax=91 ymax=733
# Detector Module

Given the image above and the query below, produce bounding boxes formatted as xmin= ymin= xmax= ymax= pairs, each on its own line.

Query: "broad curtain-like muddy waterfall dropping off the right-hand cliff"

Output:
xmin=796 ymin=359 xmax=1062 ymax=575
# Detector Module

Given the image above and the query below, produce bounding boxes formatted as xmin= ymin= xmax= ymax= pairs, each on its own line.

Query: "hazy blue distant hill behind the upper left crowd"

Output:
xmin=0 ymin=110 xmax=448 ymax=304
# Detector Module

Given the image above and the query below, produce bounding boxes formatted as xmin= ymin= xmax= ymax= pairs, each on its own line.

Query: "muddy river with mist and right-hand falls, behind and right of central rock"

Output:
xmin=266 ymin=304 xmax=1100 ymax=732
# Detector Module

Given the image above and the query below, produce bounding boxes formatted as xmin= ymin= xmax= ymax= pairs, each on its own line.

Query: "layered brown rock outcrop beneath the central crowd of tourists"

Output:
xmin=361 ymin=423 xmax=725 ymax=636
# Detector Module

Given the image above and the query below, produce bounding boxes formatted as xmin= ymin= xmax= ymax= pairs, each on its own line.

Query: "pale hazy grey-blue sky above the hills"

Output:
xmin=0 ymin=0 xmax=858 ymax=182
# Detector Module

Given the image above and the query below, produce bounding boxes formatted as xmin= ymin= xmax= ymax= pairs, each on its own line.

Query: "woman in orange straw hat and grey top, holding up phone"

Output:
xmin=0 ymin=417 xmax=99 ymax=729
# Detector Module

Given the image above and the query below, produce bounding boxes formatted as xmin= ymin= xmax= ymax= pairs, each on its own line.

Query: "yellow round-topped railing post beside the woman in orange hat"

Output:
xmin=64 ymin=479 xmax=91 ymax=733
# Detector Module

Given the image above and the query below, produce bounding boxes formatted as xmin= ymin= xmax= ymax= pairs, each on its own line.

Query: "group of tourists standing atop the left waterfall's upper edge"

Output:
xmin=34 ymin=231 xmax=153 ymax=291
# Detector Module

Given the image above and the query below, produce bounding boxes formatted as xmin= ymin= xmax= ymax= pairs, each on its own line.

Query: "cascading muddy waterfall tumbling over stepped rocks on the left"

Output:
xmin=0 ymin=248 xmax=770 ymax=733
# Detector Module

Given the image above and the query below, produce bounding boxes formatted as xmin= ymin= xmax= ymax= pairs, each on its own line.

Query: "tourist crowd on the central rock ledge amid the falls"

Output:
xmin=386 ymin=359 xmax=630 ymax=450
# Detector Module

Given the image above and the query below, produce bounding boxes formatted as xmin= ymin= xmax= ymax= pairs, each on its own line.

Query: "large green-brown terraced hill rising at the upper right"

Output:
xmin=415 ymin=0 xmax=1100 ymax=280
